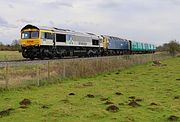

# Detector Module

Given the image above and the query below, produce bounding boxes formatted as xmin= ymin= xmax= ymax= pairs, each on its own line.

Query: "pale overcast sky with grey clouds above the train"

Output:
xmin=0 ymin=0 xmax=180 ymax=45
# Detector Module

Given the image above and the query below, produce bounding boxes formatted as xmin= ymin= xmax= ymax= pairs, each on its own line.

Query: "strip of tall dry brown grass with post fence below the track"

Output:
xmin=0 ymin=54 xmax=170 ymax=88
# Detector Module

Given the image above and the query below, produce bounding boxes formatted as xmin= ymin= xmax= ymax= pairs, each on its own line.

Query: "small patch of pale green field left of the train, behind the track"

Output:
xmin=0 ymin=51 xmax=23 ymax=61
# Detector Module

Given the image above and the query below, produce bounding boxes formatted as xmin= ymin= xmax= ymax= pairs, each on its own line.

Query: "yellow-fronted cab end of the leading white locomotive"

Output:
xmin=20 ymin=25 xmax=54 ymax=59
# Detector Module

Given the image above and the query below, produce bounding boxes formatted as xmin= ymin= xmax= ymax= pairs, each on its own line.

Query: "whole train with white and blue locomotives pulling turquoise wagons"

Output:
xmin=20 ymin=25 xmax=156 ymax=59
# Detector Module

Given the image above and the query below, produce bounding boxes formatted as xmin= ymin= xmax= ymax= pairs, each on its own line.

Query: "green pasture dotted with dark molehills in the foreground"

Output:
xmin=0 ymin=58 xmax=180 ymax=122
